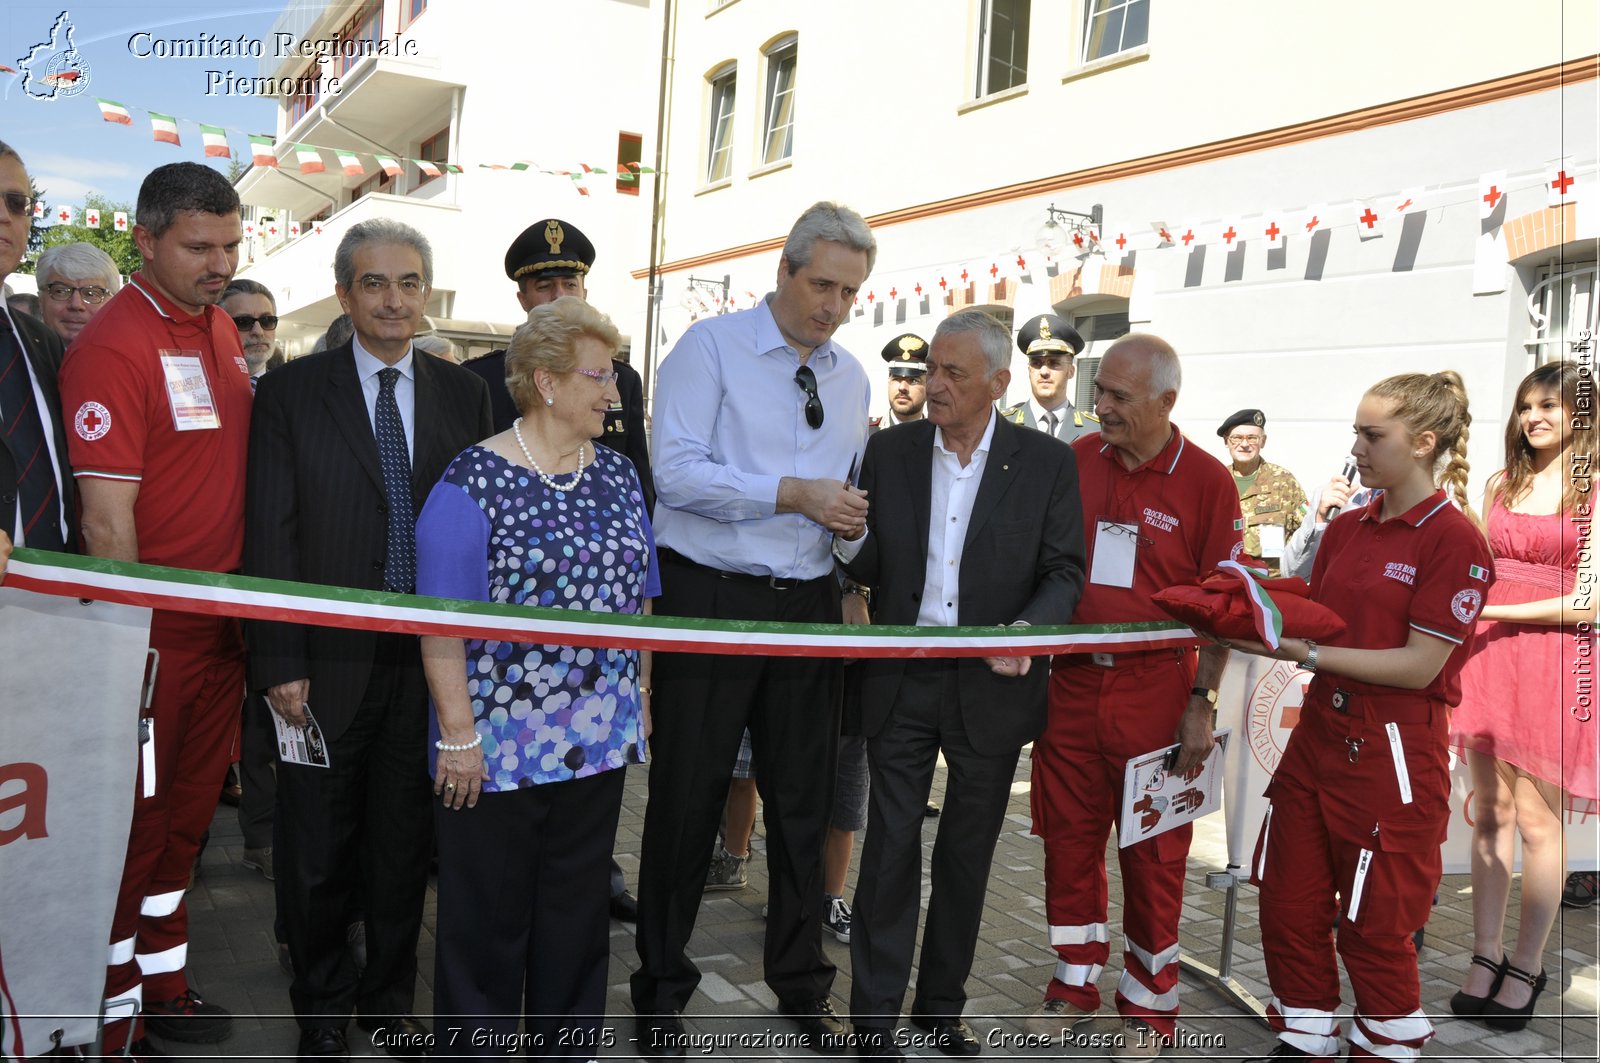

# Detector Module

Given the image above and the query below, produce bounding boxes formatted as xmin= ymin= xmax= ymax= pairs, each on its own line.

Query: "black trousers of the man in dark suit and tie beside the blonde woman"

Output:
xmin=274 ymin=634 xmax=434 ymax=1026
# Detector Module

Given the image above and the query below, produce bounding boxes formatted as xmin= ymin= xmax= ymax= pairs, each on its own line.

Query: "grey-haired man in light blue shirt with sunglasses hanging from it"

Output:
xmin=632 ymin=203 xmax=877 ymax=1058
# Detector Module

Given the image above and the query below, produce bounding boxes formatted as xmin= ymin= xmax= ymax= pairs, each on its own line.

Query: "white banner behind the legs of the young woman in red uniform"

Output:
xmin=1218 ymin=653 xmax=1600 ymax=877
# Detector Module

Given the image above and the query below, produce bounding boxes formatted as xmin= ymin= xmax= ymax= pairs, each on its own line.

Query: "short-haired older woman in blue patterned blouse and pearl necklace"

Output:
xmin=416 ymin=296 xmax=661 ymax=1058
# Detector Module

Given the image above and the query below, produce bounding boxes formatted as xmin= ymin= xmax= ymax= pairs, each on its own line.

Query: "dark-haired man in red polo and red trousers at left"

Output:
xmin=61 ymin=163 xmax=250 ymax=1057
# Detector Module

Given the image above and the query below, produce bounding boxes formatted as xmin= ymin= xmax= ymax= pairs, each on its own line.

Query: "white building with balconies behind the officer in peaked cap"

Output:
xmin=238 ymin=0 xmax=659 ymax=355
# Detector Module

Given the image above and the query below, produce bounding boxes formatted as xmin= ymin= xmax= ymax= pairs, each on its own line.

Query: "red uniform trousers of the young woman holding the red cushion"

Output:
xmin=1251 ymin=682 xmax=1450 ymax=1060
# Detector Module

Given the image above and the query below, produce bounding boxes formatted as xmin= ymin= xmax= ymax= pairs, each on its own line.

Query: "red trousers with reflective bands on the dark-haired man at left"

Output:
xmin=106 ymin=612 xmax=245 ymax=1050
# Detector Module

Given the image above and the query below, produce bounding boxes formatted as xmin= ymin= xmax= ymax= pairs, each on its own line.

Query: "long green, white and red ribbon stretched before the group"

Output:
xmin=3 ymin=549 xmax=1197 ymax=656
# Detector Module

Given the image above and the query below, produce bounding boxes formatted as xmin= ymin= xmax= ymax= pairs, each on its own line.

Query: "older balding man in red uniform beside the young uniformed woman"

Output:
xmin=1029 ymin=335 xmax=1242 ymax=1058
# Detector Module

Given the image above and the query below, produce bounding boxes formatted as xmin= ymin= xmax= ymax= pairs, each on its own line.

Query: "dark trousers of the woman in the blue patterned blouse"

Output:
xmin=434 ymin=768 xmax=626 ymax=1060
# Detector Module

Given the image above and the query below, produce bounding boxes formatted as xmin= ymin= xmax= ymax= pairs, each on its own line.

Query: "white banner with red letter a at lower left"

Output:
xmin=0 ymin=588 xmax=150 ymax=1060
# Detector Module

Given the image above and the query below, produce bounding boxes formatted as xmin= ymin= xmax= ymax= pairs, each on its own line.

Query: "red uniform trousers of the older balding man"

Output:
xmin=1032 ymin=650 xmax=1197 ymax=1037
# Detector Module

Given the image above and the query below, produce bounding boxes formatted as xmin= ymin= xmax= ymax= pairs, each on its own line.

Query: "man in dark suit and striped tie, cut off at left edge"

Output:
xmin=0 ymin=141 xmax=77 ymax=551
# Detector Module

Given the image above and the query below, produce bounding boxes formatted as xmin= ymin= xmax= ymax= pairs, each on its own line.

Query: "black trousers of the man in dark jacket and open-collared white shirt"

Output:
xmin=850 ymin=660 xmax=1021 ymax=1026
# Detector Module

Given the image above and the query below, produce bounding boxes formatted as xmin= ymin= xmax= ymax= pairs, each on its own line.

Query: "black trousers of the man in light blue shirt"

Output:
xmin=632 ymin=554 xmax=842 ymax=1015
